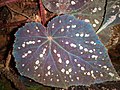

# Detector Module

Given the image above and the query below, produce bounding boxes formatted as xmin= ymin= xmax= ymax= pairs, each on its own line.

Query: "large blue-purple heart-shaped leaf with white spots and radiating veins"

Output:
xmin=13 ymin=15 xmax=119 ymax=88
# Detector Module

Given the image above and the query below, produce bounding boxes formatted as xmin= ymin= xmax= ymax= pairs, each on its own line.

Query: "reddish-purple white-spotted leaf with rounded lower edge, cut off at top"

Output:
xmin=43 ymin=0 xmax=90 ymax=14
